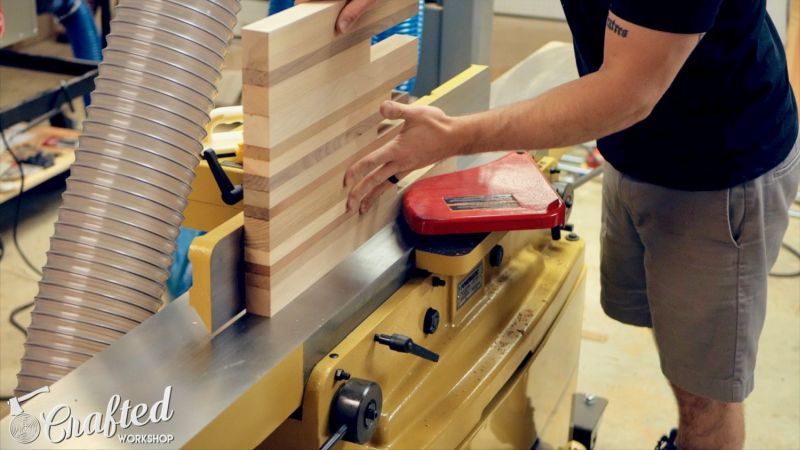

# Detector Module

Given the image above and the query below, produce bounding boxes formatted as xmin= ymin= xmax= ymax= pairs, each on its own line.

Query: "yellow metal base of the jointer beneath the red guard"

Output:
xmin=263 ymin=231 xmax=585 ymax=449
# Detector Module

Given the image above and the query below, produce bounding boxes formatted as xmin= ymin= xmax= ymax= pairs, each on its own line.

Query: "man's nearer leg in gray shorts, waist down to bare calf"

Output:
xmin=631 ymin=143 xmax=800 ymax=450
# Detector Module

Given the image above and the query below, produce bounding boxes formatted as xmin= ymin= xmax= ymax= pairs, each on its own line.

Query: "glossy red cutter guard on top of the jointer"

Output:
xmin=403 ymin=152 xmax=566 ymax=235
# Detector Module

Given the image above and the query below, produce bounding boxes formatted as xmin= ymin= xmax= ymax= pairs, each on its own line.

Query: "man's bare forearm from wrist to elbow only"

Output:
xmin=453 ymin=70 xmax=654 ymax=154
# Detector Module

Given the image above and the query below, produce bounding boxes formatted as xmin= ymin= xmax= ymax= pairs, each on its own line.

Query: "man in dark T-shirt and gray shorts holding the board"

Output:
xmin=314 ymin=0 xmax=800 ymax=449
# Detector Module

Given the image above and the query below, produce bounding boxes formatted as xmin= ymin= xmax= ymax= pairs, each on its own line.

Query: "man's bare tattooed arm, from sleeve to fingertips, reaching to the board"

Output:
xmin=345 ymin=13 xmax=702 ymax=212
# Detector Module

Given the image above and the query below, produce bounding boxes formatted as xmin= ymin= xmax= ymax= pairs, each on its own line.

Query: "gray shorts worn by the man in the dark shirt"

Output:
xmin=601 ymin=137 xmax=800 ymax=402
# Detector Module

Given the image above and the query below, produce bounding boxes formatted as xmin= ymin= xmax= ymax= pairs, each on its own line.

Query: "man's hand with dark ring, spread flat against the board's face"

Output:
xmin=344 ymin=102 xmax=465 ymax=214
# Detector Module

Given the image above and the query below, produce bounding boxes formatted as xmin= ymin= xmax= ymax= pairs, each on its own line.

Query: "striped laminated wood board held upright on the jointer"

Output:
xmin=243 ymin=0 xmax=488 ymax=316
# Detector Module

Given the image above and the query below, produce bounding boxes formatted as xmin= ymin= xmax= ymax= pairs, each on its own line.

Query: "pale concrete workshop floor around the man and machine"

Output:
xmin=0 ymin=12 xmax=800 ymax=450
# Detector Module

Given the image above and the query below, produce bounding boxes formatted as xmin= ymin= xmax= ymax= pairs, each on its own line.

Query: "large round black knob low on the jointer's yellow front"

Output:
xmin=320 ymin=379 xmax=383 ymax=450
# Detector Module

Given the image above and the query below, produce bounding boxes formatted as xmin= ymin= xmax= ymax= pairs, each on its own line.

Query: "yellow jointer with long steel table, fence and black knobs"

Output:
xmin=2 ymin=67 xmax=585 ymax=449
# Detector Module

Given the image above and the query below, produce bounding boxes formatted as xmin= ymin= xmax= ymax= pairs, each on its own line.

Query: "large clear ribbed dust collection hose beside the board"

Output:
xmin=16 ymin=0 xmax=239 ymax=395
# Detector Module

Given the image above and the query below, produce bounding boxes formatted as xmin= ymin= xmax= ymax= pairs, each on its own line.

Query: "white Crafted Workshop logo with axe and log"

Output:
xmin=8 ymin=386 xmax=174 ymax=444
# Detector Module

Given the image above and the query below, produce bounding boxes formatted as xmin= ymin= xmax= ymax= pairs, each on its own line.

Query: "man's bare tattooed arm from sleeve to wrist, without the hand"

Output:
xmin=464 ymin=14 xmax=699 ymax=152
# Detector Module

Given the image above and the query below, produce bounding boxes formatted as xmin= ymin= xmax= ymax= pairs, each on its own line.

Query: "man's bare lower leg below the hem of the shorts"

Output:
xmin=672 ymin=384 xmax=744 ymax=450
